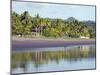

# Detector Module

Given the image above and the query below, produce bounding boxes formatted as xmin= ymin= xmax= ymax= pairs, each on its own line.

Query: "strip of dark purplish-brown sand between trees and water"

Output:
xmin=12 ymin=39 xmax=95 ymax=50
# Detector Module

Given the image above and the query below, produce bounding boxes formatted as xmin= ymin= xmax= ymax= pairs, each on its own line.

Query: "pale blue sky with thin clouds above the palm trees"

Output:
xmin=12 ymin=1 xmax=95 ymax=21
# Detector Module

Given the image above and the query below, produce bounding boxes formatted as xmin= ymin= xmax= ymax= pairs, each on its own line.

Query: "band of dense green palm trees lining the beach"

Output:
xmin=12 ymin=11 xmax=95 ymax=38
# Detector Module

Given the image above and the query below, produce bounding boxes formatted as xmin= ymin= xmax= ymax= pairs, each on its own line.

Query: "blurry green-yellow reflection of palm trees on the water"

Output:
xmin=12 ymin=46 xmax=95 ymax=70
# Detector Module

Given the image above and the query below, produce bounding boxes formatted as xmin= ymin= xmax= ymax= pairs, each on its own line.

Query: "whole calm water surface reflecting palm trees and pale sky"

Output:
xmin=11 ymin=45 xmax=95 ymax=73
